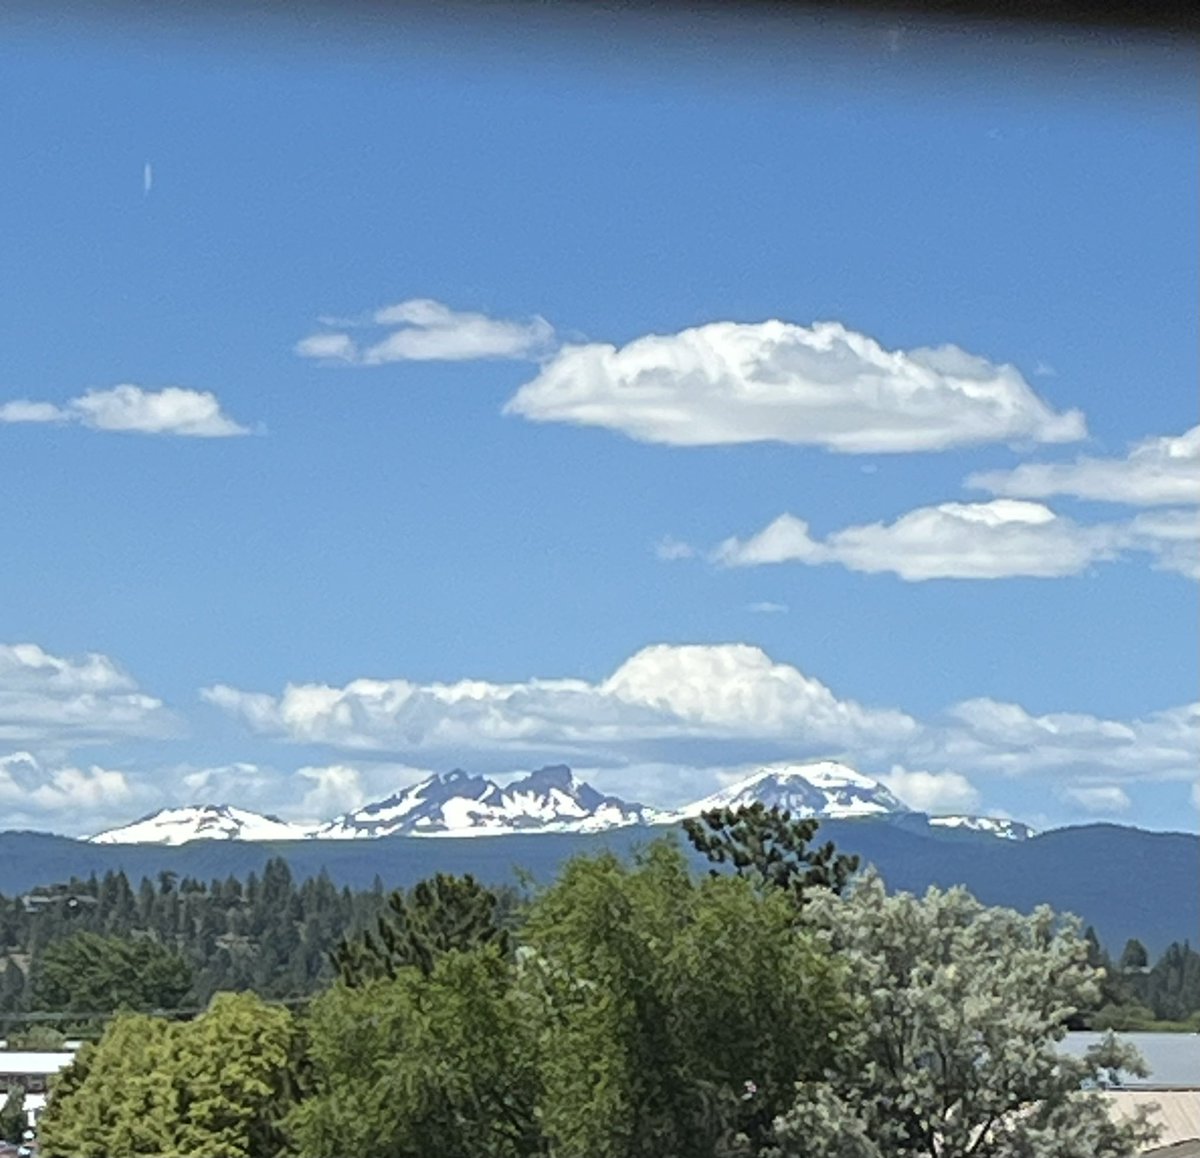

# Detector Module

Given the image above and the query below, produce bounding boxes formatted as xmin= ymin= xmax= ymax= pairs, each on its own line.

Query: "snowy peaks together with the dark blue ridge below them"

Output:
xmin=0 ymin=762 xmax=1200 ymax=953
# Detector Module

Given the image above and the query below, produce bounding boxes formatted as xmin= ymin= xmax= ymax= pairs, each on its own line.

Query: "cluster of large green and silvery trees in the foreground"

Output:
xmin=21 ymin=806 xmax=1180 ymax=1158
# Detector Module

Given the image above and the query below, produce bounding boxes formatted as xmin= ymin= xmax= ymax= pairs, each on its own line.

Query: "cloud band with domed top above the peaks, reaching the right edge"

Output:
xmin=204 ymin=644 xmax=1200 ymax=810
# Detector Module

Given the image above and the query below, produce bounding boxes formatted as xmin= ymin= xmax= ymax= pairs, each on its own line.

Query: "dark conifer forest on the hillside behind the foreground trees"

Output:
xmin=0 ymin=844 xmax=1200 ymax=1027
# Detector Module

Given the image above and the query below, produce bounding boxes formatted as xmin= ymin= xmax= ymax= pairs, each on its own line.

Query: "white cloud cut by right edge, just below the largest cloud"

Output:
xmin=967 ymin=426 xmax=1200 ymax=506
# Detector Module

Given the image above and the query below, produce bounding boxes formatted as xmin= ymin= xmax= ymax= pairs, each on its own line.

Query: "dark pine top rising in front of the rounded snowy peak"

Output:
xmin=683 ymin=803 xmax=858 ymax=902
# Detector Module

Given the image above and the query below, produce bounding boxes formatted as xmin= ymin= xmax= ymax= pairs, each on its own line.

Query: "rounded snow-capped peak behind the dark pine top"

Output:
xmin=672 ymin=760 xmax=910 ymax=820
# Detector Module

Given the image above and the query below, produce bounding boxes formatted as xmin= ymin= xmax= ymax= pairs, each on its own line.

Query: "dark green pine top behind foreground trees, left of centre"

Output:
xmin=334 ymin=872 xmax=510 ymax=985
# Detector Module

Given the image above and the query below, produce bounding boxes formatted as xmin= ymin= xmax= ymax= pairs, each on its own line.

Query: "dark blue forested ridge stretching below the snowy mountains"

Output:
xmin=0 ymin=812 xmax=1200 ymax=956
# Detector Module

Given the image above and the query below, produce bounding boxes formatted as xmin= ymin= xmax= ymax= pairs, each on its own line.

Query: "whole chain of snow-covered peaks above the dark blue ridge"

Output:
xmin=90 ymin=761 xmax=1032 ymax=845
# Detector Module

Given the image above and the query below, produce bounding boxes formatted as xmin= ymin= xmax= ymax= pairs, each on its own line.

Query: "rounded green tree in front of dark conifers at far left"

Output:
xmin=32 ymin=932 xmax=192 ymax=1013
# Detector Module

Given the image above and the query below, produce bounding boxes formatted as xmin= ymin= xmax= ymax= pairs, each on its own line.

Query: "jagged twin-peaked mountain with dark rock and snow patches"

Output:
xmin=313 ymin=764 xmax=658 ymax=840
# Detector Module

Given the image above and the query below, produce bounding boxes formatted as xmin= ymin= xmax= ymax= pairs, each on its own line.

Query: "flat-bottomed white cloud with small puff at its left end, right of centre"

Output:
xmin=715 ymin=499 xmax=1128 ymax=582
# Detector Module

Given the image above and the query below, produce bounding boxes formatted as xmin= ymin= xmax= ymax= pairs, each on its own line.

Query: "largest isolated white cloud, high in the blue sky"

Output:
xmin=505 ymin=322 xmax=1085 ymax=454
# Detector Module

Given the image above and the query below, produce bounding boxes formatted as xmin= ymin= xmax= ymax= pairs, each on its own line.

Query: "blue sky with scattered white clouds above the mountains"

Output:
xmin=0 ymin=8 xmax=1200 ymax=833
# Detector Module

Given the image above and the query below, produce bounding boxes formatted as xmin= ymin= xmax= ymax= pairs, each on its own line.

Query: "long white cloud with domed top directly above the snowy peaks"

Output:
xmin=203 ymin=644 xmax=916 ymax=758
